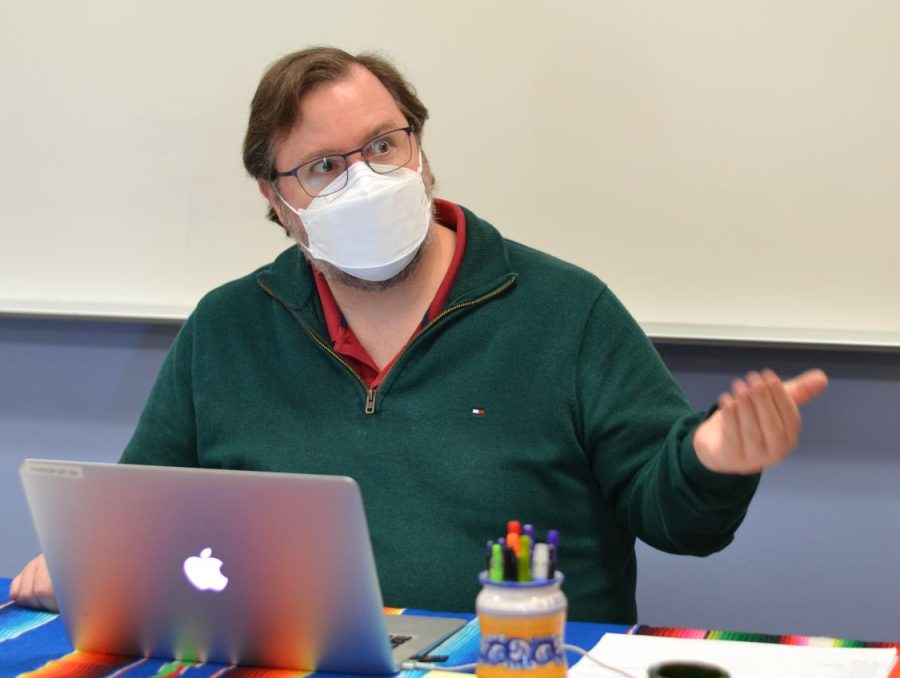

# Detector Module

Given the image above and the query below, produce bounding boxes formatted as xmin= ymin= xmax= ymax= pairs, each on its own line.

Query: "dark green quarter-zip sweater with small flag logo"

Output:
xmin=122 ymin=205 xmax=758 ymax=623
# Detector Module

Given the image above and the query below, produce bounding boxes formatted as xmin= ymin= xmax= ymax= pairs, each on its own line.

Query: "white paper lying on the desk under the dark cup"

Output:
xmin=569 ymin=633 xmax=897 ymax=678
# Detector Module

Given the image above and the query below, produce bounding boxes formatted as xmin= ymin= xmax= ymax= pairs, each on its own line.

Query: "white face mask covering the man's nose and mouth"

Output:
xmin=279 ymin=152 xmax=431 ymax=282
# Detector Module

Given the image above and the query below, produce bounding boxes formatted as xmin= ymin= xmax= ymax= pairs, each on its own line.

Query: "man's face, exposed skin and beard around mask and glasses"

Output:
xmin=260 ymin=66 xmax=431 ymax=289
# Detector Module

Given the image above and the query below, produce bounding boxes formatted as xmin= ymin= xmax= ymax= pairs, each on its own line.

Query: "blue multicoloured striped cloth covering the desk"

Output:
xmin=0 ymin=578 xmax=900 ymax=678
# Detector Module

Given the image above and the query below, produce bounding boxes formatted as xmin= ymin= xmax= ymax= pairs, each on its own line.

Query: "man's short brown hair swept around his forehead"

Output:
xmin=244 ymin=47 xmax=428 ymax=224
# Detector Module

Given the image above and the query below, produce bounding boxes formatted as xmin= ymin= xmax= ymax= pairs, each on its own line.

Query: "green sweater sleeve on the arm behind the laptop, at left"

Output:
xmin=119 ymin=316 xmax=199 ymax=466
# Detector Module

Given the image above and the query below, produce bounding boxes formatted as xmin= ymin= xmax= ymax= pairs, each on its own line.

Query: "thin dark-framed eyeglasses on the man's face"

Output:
xmin=275 ymin=125 xmax=413 ymax=198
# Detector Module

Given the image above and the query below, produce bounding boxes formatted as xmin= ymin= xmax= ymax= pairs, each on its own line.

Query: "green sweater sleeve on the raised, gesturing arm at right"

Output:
xmin=577 ymin=289 xmax=759 ymax=555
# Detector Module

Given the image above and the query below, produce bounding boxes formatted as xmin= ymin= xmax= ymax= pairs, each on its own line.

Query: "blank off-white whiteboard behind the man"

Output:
xmin=0 ymin=0 xmax=900 ymax=347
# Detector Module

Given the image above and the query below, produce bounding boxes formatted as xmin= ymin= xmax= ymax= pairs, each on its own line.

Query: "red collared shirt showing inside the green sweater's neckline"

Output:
xmin=313 ymin=198 xmax=466 ymax=388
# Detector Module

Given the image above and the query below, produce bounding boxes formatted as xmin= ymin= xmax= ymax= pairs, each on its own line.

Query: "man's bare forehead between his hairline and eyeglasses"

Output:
xmin=276 ymin=66 xmax=407 ymax=167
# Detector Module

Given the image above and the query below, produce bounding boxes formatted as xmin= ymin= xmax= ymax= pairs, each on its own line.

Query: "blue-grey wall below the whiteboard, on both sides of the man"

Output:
xmin=0 ymin=318 xmax=900 ymax=640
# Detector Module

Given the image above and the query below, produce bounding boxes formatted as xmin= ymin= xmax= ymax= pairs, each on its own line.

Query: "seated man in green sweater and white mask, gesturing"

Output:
xmin=12 ymin=48 xmax=826 ymax=622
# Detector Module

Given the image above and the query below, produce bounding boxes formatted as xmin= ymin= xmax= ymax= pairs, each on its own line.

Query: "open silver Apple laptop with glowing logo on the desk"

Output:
xmin=19 ymin=459 xmax=465 ymax=675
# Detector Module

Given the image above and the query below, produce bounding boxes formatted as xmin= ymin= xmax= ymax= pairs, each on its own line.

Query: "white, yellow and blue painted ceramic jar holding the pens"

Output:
xmin=475 ymin=572 xmax=568 ymax=678
